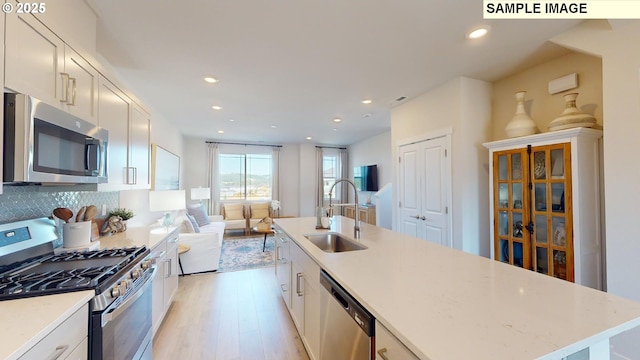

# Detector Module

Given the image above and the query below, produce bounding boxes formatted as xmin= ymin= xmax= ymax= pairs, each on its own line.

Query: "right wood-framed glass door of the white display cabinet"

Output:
xmin=531 ymin=143 xmax=574 ymax=281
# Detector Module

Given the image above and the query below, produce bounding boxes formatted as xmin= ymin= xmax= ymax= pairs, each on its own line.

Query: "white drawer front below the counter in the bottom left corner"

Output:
xmin=20 ymin=304 xmax=89 ymax=360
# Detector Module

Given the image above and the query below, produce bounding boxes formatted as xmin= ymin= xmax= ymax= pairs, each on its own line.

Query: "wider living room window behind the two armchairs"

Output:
xmin=219 ymin=154 xmax=273 ymax=201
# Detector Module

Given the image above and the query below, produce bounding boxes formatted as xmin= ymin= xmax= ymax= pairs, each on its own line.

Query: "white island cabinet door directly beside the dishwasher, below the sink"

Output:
xmin=289 ymin=242 xmax=320 ymax=359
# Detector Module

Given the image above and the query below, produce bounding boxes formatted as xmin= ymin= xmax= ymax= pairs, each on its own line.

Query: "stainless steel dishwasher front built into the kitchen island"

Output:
xmin=320 ymin=270 xmax=375 ymax=360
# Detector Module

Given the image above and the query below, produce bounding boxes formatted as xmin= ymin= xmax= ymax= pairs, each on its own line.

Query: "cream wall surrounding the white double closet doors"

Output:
xmin=391 ymin=77 xmax=491 ymax=256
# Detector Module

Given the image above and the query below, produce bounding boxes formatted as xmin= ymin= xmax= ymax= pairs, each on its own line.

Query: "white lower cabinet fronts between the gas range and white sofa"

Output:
xmin=151 ymin=230 xmax=178 ymax=336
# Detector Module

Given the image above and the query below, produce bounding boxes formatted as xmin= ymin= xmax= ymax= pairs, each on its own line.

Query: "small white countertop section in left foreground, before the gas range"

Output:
xmin=0 ymin=290 xmax=94 ymax=359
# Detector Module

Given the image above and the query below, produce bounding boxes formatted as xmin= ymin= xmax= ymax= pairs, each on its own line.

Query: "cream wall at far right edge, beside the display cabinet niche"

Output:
xmin=552 ymin=20 xmax=640 ymax=358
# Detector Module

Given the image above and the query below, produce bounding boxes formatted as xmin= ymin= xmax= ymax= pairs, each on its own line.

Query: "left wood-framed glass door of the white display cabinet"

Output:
xmin=493 ymin=149 xmax=531 ymax=269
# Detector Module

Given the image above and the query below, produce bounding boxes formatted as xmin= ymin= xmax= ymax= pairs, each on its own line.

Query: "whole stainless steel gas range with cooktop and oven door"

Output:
xmin=0 ymin=218 xmax=155 ymax=360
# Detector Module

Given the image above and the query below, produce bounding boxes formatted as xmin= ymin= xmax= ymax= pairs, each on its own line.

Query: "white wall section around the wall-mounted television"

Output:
xmin=348 ymin=131 xmax=393 ymax=205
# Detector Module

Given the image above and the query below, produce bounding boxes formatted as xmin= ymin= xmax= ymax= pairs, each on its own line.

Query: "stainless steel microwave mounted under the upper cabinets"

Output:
xmin=2 ymin=93 xmax=109 ymax=184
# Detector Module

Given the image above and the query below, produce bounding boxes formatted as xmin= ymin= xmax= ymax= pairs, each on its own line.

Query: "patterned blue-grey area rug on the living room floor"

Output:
xmin=218 ymin=235 xmax=275 ymax=272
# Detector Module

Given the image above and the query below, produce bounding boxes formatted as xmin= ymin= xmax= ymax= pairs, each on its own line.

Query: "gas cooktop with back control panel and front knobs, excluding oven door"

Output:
xmin=0 ymin=218 xmax=152 ymax=311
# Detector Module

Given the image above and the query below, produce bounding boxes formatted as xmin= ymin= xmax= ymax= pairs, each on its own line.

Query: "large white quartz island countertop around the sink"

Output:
xmin=275 ymin=217 xmax=640 ymax=360
